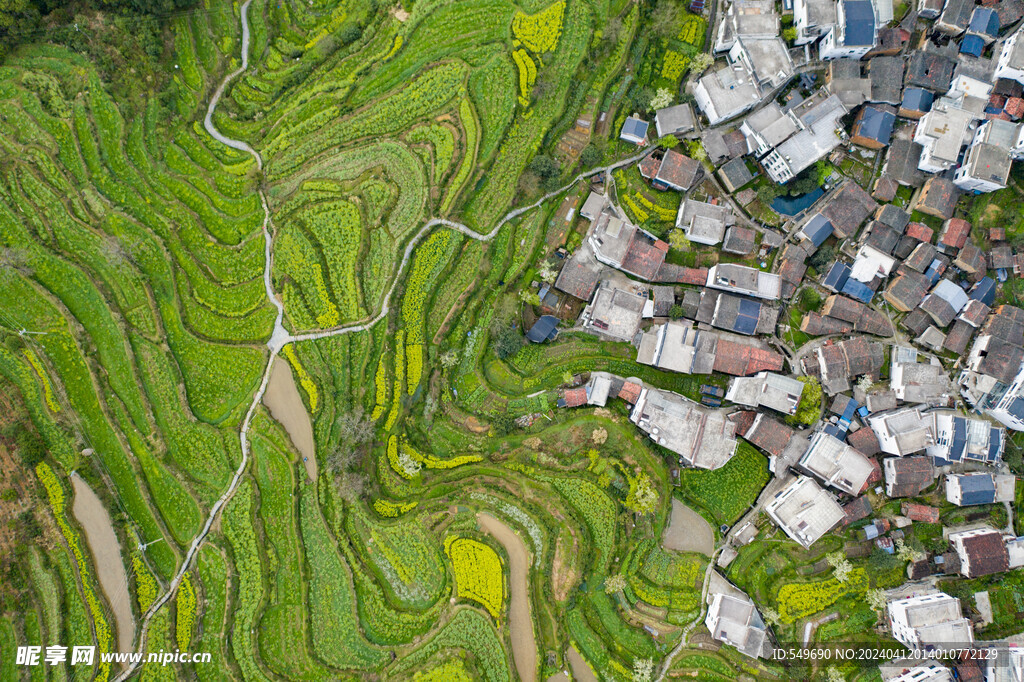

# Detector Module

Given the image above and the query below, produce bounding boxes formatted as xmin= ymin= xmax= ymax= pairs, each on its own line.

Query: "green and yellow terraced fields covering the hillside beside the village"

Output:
xmin=0 ymin=0 xmax=761 ymax=681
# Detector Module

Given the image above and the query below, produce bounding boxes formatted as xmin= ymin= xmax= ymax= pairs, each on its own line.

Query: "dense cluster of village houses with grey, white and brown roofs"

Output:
xmin=520 ymin=0 xmax=1024 ymax=667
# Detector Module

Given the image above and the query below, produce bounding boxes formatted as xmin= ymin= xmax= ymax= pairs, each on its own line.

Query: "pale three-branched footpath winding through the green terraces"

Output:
xmin=114 ymin=0 xmax=655 ymax=682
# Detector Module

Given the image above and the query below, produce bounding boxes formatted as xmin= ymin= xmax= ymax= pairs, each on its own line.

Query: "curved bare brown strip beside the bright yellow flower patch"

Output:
xmin=476 ymin=512 xmax=538 ymax=682
